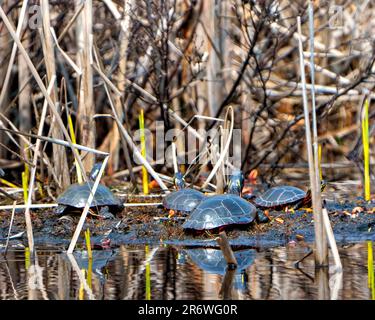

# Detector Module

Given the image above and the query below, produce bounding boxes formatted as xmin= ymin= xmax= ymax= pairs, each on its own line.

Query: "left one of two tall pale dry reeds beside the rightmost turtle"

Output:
xmin=297 ymin=16 xmax=328 ymax=266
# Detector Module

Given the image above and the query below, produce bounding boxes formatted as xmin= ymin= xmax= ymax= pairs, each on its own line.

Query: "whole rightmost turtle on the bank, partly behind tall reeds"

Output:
xmin=255 ymin=180 xmax=326 ymax=209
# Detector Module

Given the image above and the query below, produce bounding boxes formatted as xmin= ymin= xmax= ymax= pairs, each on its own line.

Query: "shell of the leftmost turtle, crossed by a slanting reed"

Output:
xmin=57 ymin=182 xmax=121 ymax=208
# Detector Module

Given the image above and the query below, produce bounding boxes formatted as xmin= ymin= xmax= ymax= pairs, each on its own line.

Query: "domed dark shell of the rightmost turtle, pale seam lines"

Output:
xmin=255 ymin=186 xmax=306 ymax=208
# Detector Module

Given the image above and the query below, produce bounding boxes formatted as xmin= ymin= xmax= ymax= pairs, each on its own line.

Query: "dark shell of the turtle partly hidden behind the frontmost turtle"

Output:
xmin=163 ymin=188 xmax=206 ymax=212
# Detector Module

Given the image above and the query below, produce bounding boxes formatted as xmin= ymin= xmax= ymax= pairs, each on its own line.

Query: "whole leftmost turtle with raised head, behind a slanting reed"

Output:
xmin=55 ymin=163 xmax=124 ymax=218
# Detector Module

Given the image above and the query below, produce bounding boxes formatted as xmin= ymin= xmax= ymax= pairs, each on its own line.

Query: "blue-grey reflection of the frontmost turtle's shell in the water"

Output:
xmin=186 ymin=248 xmax=256 ymax=275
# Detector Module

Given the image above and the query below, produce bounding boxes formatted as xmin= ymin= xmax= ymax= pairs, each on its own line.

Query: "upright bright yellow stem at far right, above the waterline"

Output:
xmin=362 ymin=98 xmax=371 ymax=201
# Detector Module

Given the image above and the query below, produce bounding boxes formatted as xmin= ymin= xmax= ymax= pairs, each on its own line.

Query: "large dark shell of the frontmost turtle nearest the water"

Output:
xmin=182 ymin=194 xmax=257 ymax=230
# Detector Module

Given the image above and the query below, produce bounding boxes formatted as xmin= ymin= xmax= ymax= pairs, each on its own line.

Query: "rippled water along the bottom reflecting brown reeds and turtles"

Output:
xmin=0 ymin=243 xmax=374 ymax=300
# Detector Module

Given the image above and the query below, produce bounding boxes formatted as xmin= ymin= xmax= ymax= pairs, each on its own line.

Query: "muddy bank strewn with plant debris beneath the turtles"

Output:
xmin=0 ymin=195 xmax=375 ymax=249
